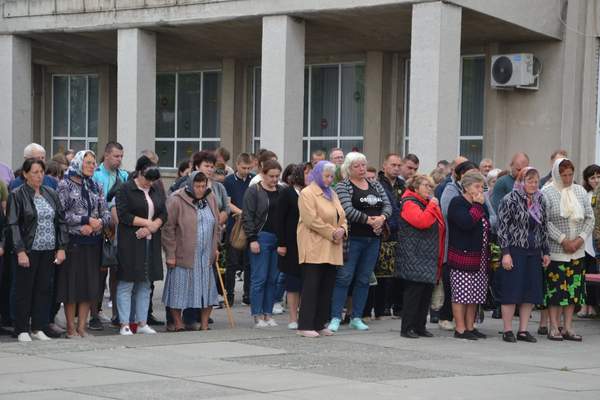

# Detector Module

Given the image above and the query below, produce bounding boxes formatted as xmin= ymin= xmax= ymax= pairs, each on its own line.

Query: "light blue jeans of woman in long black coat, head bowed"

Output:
xmin=117 ymin=281 xmax=150 ymax=324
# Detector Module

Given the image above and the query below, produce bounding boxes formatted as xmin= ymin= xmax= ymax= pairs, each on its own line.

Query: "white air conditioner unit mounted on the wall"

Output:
xmin=491 ymin=53 xmax=541 ymax=89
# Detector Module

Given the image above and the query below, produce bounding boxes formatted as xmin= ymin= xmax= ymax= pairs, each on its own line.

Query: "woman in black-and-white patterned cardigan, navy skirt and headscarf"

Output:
xmin=495 ymin=167 xmax=550 ymax=343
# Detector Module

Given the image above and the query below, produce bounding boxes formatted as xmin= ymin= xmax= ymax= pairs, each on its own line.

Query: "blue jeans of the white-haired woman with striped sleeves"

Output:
xmin=331 ymin=237 xmax=380 ymax=318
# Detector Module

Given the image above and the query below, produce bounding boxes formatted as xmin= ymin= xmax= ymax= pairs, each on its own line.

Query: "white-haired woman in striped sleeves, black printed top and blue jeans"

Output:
xmin=329 ymin=152 xmax=392 ymax=332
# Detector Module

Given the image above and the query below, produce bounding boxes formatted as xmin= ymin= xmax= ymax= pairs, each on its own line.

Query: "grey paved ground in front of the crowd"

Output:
xmin=0 ymin=282 xmax=600 ymax=400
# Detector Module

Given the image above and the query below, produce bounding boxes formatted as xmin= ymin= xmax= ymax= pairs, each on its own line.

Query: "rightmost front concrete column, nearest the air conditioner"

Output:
xmin=409 ymin=2 xmax=462 ymax=171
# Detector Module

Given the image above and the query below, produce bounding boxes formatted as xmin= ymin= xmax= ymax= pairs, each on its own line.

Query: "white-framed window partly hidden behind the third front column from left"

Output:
xmin=252 ymin=63 xmax=365 ymax=160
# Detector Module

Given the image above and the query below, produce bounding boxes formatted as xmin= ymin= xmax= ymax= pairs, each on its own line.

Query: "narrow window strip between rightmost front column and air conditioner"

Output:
xmin=459 ymin=55 xmax=485 ymax=163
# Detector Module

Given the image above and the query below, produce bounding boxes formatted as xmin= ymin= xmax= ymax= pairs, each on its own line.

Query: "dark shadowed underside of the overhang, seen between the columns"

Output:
xmin=17 ymin=0 xmax=564 ymax=65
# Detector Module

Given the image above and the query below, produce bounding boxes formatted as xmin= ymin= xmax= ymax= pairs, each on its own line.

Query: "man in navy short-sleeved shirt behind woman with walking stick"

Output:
xmin=223 ymin=153 xmax=254 ymax=305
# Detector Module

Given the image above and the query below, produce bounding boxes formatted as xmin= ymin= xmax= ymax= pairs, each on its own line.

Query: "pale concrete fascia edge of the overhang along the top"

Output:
xmin=0 ymin=0 xmax=564 ymax=39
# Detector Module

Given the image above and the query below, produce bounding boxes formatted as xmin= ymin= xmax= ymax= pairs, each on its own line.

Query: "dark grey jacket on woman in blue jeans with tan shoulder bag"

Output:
xmin=242 ymin=183 xmax=283 ymax=243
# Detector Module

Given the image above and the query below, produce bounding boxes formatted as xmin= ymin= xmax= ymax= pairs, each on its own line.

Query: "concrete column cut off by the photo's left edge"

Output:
xmin=0 ymin=35 xmax=33 ymax=168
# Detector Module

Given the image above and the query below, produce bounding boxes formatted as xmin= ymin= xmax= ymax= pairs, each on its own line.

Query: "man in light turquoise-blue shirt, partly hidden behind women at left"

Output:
xmin=89 ymin=142 xmax=129 ymax=330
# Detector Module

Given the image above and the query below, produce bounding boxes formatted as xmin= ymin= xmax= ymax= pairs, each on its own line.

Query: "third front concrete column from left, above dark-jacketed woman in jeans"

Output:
xmin=260 ymin=15 xmax=305 ymax=165
